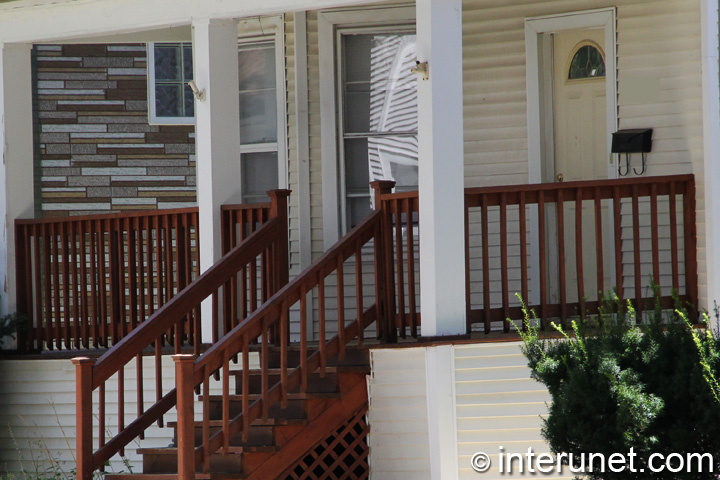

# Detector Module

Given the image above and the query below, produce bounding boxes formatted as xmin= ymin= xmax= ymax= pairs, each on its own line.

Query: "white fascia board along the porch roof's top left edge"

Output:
xmin=0 ymin=0 xmax=367 ymax=43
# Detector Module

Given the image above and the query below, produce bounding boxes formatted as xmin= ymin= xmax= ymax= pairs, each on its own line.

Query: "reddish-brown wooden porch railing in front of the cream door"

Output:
xmin=465 ymin=175 xmax=698 ymax=333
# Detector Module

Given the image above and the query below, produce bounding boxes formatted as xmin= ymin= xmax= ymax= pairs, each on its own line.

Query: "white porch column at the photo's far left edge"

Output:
xmin=0 ymin=44 xmax=34 ymax=315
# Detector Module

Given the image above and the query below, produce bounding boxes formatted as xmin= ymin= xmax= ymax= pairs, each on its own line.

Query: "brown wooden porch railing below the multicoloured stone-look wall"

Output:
xmin=15 ymin=208 xmax=199 ymax=350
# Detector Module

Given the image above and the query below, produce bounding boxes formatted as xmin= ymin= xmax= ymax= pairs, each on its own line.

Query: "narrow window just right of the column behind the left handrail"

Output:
xmin=238 ymin=41 xmax=280 ymax=203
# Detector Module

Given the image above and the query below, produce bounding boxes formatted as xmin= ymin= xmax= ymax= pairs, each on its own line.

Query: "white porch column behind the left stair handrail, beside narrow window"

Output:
xmin=193 ymin=19 xmax=240 ymax=342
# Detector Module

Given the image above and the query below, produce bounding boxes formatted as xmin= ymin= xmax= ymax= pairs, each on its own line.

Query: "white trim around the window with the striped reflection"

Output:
xmin=318 ymin=5 xmax=415 ymax=249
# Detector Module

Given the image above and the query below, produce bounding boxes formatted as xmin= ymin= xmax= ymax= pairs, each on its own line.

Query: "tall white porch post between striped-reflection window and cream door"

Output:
xmin=416 ymin=0 xmax=466 ymax=336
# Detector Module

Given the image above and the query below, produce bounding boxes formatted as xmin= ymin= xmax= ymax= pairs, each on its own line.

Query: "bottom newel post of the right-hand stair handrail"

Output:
xmin=173 ymin=354 xmax=195 ymax=480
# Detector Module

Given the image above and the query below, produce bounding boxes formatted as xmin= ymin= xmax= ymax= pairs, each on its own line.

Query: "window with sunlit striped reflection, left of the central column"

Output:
xmin=339 ymin=29 xmax=418 ymax=230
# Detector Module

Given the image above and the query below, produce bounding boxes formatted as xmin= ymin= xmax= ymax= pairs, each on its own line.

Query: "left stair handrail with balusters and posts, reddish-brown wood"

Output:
xmin=72 ymin=190 xmax=290 ymax=480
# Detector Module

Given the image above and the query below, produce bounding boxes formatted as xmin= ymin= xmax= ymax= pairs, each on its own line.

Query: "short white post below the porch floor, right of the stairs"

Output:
xmin=425 ymin=345 xmax=458 ymax=480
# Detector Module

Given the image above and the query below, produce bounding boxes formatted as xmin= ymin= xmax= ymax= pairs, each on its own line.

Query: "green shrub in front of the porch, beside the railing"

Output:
xmin=522 ymin=292 xmax=720 ymax=480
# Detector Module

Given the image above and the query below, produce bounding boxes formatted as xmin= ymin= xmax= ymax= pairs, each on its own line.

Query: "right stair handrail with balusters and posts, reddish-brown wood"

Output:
xmin=175 ymin=182 xmax=394 ymax=474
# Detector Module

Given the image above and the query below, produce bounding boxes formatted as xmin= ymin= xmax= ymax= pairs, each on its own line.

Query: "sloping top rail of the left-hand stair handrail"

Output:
xmin=93 ymin=218 xmax=281 ymax=388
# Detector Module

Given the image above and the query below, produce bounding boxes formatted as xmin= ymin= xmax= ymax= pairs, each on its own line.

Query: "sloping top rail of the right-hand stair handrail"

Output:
xmin=195 ymin=210 xmax=382 ymax=380
